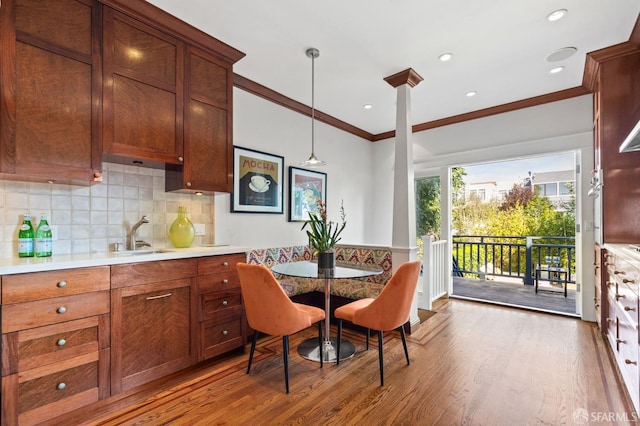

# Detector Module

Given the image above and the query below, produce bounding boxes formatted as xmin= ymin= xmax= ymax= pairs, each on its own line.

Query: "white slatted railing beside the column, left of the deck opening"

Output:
xmin=418 ymin=235 xmax=451 ymax=310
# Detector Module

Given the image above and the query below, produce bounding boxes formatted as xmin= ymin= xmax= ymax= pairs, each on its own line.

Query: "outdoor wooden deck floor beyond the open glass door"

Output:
xmin=451 ymin=277 xmax=579 ymax=316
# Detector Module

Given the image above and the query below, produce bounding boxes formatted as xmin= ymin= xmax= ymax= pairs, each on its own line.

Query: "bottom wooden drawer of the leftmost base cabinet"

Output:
xmin=18 ymin=353 xmax=99 ymax=415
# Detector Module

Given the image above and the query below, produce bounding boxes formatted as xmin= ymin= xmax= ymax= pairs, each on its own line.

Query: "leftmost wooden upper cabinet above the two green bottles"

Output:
xmin=0 ymin=0 xmax=102 ymax=183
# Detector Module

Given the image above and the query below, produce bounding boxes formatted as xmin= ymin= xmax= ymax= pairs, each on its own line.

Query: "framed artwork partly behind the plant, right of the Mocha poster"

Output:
xmin=289 ymin=166 xmax=327 ymax=222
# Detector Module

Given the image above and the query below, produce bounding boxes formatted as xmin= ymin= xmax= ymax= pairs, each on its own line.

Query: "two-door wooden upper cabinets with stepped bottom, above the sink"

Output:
xmin=102 ymin=0 xmax=244 ymax=192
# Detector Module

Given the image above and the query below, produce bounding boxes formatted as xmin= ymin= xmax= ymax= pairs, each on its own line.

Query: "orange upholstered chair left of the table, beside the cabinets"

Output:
xmin=236 ymin=263 xmax=324 ymax=393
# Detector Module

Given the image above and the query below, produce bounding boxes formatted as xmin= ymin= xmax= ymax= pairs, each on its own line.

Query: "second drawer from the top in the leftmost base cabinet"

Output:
xmin=2 ymin=291 xmax=110 ymax=333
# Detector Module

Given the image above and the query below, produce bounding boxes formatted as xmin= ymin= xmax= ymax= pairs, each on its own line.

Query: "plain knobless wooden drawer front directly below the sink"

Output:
xmin=111 ymin=259 xmax=197 ymax=288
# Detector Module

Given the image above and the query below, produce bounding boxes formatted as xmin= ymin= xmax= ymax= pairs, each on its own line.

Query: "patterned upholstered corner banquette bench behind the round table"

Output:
xmin=247 ymin=245 xmax=392 ymax=322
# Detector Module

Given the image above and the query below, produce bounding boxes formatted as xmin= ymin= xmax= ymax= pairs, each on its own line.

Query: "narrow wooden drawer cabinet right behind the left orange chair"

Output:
xmin=198 ymin=253 xmax=246 ymax=361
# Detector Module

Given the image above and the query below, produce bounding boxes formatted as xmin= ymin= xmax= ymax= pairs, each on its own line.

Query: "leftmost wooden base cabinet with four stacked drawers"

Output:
xmin=1 ymin=266 xmax=110 ymax=425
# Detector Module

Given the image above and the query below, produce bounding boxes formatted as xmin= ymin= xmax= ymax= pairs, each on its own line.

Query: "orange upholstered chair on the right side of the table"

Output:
xmin=335 ymin=260 xmax=420 ymax=386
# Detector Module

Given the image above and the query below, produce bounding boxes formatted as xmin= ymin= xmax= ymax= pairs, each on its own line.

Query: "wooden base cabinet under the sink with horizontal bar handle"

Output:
xmin=111 ymin=259 xmax=197 ymax=394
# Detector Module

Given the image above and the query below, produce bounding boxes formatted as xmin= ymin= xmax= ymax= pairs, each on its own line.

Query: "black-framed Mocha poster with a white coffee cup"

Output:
xmin=231 ymin=146 xmax=284 ymax=214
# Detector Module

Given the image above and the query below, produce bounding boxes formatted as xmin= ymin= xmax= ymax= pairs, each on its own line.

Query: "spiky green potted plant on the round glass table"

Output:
xmin=302 ymin=199 xmax=347 ymax=269
